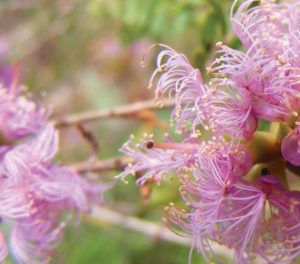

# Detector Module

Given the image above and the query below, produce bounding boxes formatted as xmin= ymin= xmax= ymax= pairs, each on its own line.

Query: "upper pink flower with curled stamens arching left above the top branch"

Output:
xmin=149 ymin=45 xmax=206 ymax=134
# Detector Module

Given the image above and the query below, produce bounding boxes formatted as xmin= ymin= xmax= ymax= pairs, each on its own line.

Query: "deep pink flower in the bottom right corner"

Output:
xmin=255 ymin=175 xmax=300 ymax=263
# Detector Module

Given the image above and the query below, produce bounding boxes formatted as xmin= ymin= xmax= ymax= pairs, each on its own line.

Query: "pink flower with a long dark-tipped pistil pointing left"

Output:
xmin=118 ymin=135 xmax=198 ymax=184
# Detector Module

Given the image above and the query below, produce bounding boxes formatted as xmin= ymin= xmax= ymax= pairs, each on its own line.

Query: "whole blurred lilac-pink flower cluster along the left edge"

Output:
xmin=0 ymin=65 xmax=105 ymax=264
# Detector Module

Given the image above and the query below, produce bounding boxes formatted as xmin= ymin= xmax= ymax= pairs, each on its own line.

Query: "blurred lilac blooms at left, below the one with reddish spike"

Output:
xmin=0 ymin=124 xmax=109 ymax=263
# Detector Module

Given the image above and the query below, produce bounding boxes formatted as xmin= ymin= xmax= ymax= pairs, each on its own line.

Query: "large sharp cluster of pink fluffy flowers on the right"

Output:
xmin=120 ymin=0 xmax=300 ymax=263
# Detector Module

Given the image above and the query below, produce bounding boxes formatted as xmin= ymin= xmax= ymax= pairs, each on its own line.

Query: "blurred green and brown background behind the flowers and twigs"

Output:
xmin=0 ymin=0 xmax=240 ymax=264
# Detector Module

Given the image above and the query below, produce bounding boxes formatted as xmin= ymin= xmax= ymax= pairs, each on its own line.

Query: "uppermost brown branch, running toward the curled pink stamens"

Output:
xmin=54 ymin=99 xmax=175 ymax=127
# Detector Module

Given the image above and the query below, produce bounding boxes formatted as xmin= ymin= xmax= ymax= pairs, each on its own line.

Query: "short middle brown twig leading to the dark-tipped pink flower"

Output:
xmin=68 ymin=157 xmax=131 ymax=173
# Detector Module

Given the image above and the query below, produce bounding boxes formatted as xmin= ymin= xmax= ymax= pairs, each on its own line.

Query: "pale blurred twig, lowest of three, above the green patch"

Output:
xmin=86 ymin=206 xmax=233 ymax=259
